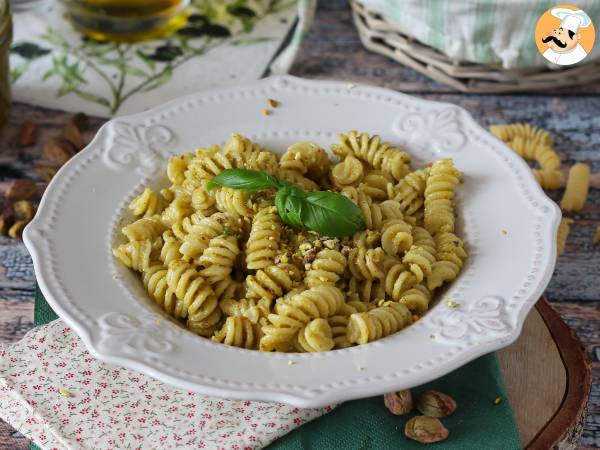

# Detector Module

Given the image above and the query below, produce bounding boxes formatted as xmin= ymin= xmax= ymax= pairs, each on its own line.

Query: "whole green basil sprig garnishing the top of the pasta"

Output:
xmin=207 ymin=169 xmax=365 ymax=237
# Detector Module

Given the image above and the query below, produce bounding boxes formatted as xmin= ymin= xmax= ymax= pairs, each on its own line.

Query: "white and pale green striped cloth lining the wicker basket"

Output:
xmin=360 ymin=0 xmax=600 ymax=69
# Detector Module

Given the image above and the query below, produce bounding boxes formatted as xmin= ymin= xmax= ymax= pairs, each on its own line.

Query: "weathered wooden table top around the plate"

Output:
xmin=0 ymin=0 xmax=600 ymax=450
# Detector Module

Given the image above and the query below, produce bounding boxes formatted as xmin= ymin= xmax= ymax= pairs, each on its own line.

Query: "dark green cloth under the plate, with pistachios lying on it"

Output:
xmin=30 ymin=289 xmax=521 ymax=450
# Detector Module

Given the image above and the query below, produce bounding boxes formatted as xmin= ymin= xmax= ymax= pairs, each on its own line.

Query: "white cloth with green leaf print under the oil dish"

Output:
xmin=10 ymin=0 xmax=316 ymax=117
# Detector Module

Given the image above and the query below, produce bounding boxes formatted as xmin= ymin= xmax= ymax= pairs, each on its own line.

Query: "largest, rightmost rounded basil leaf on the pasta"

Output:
xmin=300 ymin=191 xmax=365 ymax=237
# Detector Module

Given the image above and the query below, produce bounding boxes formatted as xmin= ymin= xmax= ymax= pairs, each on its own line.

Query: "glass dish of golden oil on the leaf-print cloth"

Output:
xmin=63 ymin=0 xmax=190 ymax=42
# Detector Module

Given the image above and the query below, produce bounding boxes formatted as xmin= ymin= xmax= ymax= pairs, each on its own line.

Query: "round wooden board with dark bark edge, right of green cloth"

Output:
xmin=498 ymin=297 xmax=592 ymax=450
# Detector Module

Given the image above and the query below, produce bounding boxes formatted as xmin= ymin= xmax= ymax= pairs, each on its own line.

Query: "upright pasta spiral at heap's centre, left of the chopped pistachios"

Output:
xmin=246 ymin=206 xmax=281 ymax=269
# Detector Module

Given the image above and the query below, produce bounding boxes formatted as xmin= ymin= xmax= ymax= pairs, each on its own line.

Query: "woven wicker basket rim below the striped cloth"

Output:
xmin=350 ymin=0 xmax=600 ymax=93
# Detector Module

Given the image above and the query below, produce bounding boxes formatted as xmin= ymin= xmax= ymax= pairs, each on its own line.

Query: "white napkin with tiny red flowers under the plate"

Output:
xmin=0 ymin=320 xmax=331 ymax=450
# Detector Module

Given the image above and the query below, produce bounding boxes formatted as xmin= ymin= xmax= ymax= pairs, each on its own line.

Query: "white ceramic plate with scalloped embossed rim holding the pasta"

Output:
xmin=24 ymin=77 xmax=560 ymax=407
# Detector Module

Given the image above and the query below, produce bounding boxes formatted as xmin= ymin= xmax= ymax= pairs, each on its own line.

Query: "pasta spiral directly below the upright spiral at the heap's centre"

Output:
xmin=246 ymin=264 xmax=300 ymax=303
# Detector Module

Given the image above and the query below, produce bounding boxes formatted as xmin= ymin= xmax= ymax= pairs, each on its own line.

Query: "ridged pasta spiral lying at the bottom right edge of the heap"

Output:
xmin=346 ymin=302 xmax=412 ymax=344
